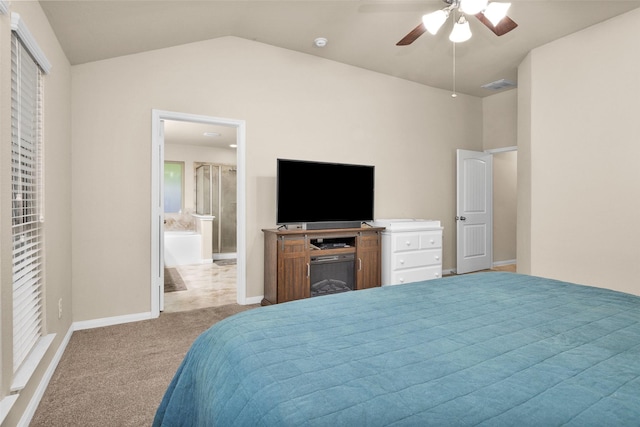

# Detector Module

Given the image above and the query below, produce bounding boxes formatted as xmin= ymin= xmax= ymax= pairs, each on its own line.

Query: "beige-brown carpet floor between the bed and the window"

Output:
xmin=30 ymin=304 xmax=259 ymax=427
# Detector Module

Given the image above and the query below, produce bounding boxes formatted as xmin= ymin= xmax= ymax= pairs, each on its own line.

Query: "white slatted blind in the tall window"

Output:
xmin=11 ymin=33 xmax=44 ymax=372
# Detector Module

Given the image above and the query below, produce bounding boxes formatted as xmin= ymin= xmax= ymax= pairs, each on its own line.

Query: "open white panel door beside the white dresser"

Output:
xmin=456 ymin=150 xmax=493 ymax=274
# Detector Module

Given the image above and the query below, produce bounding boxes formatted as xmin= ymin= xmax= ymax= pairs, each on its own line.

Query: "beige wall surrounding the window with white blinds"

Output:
xmin=0 ymin=1 xmax=72 ymax=425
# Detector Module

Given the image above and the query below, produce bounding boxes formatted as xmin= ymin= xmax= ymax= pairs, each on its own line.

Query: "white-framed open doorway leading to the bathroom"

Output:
xmin=151 ymin=110 xmax=246 ymax=316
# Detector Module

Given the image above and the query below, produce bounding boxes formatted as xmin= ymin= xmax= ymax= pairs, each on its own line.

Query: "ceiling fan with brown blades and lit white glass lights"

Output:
xmin=396 ymin=0 xmax=518 ymax=46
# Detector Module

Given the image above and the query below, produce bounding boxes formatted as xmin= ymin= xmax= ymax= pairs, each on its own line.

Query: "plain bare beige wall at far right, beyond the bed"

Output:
xmin=518 ymin=9 xmax=640 ymax=295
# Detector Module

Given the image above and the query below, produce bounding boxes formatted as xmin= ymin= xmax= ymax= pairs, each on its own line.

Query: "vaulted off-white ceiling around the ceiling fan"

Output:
xmin=40 ymin=0 xmax=640 ymax=97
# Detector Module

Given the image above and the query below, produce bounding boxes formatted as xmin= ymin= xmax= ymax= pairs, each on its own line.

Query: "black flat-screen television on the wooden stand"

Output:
xmin=276 ymin=159 xmax=375 ymax=229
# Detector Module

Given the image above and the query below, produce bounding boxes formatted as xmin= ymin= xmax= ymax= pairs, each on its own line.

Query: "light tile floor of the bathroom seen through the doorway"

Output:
xmin=164 ymin=262 xmax=237 ymax=313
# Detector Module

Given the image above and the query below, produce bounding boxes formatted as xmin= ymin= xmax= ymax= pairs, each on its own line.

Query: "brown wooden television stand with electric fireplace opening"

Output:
xmin=262 ymin=227 xmax=384 ymax=305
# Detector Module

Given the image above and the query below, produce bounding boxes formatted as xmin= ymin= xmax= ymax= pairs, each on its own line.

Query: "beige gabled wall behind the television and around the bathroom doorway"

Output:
xmin=72 ymin=37 xmax=482 ymax=320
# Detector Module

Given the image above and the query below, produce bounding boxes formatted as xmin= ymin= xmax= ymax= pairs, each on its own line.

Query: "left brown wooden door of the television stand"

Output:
xmin=278 ymin=236 xmax=311 ymax=304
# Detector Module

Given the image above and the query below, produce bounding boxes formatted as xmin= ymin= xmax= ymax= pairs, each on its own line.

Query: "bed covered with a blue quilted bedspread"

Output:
xmin=154 ymin=272 xmax=640 ymax=426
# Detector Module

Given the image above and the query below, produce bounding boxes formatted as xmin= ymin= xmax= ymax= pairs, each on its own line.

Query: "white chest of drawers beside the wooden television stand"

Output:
xmin=373 ymin=219 xmax=442 ymax=286
